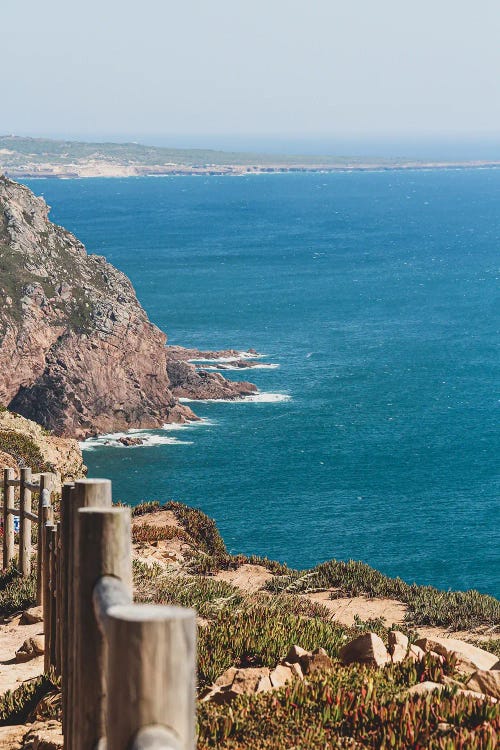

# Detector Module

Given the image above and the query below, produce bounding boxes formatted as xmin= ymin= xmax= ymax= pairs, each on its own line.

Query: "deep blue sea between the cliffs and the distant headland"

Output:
xmin=27 ymin=170 xmax=500 ymax=596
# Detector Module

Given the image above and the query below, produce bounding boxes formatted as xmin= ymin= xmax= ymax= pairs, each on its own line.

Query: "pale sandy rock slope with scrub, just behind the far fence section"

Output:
xmin=0 ymin=410 xmax=86 ymax=481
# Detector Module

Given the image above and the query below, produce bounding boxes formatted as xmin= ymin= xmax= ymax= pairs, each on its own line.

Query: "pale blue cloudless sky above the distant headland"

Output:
xmin=0 ymin=0 xmax=500 ymax=153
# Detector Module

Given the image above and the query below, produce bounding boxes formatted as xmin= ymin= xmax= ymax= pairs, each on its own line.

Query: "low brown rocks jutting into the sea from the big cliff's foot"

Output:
xmin=167 ymin=353 xmax=257 ymax=401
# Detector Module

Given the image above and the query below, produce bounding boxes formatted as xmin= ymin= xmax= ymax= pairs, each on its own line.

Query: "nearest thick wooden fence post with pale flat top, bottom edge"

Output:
xmin=106 ymin=604 xmax=196 ymax=750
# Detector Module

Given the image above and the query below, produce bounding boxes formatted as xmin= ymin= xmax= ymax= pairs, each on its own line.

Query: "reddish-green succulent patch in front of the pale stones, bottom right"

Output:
xmin=198 ymin=663 xmax=500 ymax=750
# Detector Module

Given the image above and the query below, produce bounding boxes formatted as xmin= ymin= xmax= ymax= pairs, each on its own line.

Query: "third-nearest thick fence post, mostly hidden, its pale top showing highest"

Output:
xmin=65 ymin=479 xmax=112 ymax=750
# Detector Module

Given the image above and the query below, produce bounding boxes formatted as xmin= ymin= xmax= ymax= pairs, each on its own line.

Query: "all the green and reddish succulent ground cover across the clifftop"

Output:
xmin=0 ymin=503 xmax=500 ymax=750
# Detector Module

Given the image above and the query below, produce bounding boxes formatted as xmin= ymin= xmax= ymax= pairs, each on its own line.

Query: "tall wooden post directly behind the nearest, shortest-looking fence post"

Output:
xmin=73 ymin=508 xmax=132 ymax=750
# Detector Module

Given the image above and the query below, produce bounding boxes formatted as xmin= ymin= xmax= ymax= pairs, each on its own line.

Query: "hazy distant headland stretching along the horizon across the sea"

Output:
xmin=0 ymin=135 xmax=500 ymax=179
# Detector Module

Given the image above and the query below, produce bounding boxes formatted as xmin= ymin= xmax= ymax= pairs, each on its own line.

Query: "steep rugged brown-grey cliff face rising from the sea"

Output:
xmin=0 ymin=176 xmax=194 ymax=437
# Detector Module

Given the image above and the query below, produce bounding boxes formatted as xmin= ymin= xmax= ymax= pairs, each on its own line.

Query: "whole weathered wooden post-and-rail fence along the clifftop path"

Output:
xmin=3 ymin=469 xmax=196 ymax=750
